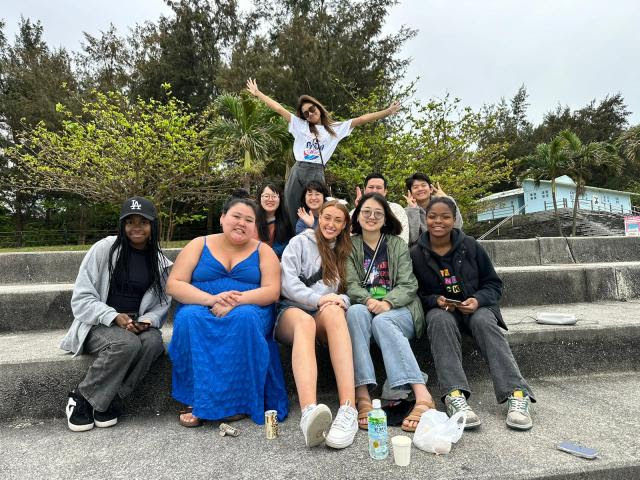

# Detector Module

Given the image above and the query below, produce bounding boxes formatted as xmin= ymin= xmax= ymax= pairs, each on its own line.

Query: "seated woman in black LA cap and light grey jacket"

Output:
xmin=60 ymin=196 xmax=171 ymax=432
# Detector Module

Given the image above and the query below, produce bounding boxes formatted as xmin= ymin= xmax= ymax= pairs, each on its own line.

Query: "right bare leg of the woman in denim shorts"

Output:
xmin=316 ymin=305 xmax=356 ymax=407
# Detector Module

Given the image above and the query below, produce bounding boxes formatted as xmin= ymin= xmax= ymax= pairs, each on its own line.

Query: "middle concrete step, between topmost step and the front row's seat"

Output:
xmin=5 ymin=261 xmax=640 ymax=332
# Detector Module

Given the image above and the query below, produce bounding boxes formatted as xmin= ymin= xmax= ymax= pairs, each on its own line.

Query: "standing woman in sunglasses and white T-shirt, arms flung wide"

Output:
xmin=247 ymin=78 xmax=400 ymax=229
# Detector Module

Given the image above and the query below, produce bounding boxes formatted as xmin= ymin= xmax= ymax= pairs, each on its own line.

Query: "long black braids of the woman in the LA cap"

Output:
xmin=109 ymin=217 xmax=169 ymax=303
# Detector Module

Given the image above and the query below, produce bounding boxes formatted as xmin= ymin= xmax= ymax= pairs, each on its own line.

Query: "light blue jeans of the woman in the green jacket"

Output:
xmin=347 ymin=304 xmax=424 ymax=388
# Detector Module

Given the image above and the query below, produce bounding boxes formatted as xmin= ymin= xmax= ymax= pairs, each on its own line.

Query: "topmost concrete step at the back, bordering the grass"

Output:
xmin=0 ymin=237 xmax=640 ymax=285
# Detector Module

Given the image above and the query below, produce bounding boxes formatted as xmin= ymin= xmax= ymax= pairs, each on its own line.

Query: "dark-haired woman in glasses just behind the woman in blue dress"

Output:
xmin=255 ymin=183 xmax=293 ymax=258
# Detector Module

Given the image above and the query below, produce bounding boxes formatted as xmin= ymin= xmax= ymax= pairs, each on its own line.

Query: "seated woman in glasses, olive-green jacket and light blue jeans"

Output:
xmin=347 ymin=192 xmax=435 ymax=432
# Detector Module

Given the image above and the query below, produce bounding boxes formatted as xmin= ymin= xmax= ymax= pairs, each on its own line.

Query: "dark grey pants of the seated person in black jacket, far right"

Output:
xmin=426 ymin=307 xmax=535 ymax=403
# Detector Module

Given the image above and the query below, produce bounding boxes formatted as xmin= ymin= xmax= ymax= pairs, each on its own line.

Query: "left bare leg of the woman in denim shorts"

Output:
xmin=276 ymin=308 xmax=318 ymax=410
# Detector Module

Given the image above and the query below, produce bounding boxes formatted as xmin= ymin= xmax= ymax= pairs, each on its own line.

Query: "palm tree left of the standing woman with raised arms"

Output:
xmin=204 ymin=94 xmax=289 ymax=191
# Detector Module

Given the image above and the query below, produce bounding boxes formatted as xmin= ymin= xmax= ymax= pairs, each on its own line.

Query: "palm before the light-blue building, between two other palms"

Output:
xmin=556 ymin=130 xmax=622 ymax=237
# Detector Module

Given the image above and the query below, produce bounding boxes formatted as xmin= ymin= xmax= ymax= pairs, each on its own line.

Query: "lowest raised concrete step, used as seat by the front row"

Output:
xmin=0 ymin=301 xmax=640 ymax=418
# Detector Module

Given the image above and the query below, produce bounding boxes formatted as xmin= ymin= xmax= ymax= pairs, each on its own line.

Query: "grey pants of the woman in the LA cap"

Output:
xmin=78 ymin=323 xmax=164 ymax=412
